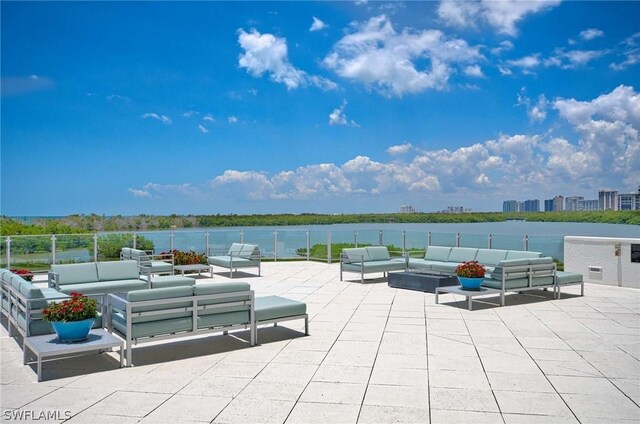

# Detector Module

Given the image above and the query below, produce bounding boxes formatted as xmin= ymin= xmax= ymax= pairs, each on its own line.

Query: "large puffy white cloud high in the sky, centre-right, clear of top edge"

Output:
xmin=323 ymin=15 xmax=483 ymax=97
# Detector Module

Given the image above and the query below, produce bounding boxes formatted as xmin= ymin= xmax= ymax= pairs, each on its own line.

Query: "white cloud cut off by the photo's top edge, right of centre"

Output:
xmin=438 ymin=0 xmax=560 ymax=36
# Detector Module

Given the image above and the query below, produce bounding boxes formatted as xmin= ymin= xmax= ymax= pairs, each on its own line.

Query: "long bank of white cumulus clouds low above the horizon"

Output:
xmin=129 ymin=85 xmax=640 ymax=205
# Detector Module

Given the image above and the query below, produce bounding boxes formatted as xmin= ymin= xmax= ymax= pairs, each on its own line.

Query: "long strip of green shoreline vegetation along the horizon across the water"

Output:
xmin=0 ymin=211 xmax=640 ymax=236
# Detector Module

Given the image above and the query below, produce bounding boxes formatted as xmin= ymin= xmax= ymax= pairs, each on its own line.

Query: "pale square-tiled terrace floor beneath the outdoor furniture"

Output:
xmin=0 ymin=262 xmax=640 ymax=424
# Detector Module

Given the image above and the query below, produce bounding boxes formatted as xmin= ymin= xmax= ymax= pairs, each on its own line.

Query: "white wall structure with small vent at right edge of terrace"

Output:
xmin=564 ymin=235 xmax=640 ymax=288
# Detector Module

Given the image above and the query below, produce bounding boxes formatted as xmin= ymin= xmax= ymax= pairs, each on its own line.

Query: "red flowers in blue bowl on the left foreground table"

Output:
xmin=42 ymin=292 xmax=98 ymax=342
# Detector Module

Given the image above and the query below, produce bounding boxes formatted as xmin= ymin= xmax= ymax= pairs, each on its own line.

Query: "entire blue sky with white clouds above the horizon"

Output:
xmin=0 ymin=1 xmax=640 ymax=215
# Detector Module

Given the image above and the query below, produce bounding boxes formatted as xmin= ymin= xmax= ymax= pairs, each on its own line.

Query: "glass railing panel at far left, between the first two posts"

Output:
xmin=5 ymin=235 xmax=53 ymax=271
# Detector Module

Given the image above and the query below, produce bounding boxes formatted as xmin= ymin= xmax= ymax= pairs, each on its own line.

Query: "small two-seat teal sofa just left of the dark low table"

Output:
xmin=340 ymin=246 xmax=407 ymax=283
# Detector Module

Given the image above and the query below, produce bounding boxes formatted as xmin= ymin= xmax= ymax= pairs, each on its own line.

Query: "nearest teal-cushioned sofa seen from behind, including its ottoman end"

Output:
xmin=107 ymin=282 xmax=309 ymax=366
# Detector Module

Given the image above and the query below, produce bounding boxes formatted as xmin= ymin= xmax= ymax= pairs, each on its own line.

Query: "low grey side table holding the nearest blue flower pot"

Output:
xmin=22 ymin=329 xmax=124 ymax=381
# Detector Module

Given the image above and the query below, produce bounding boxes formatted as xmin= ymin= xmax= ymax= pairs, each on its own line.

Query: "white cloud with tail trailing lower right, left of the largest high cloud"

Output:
xmin=238 ymin=29 xmax=337 ymax=90
